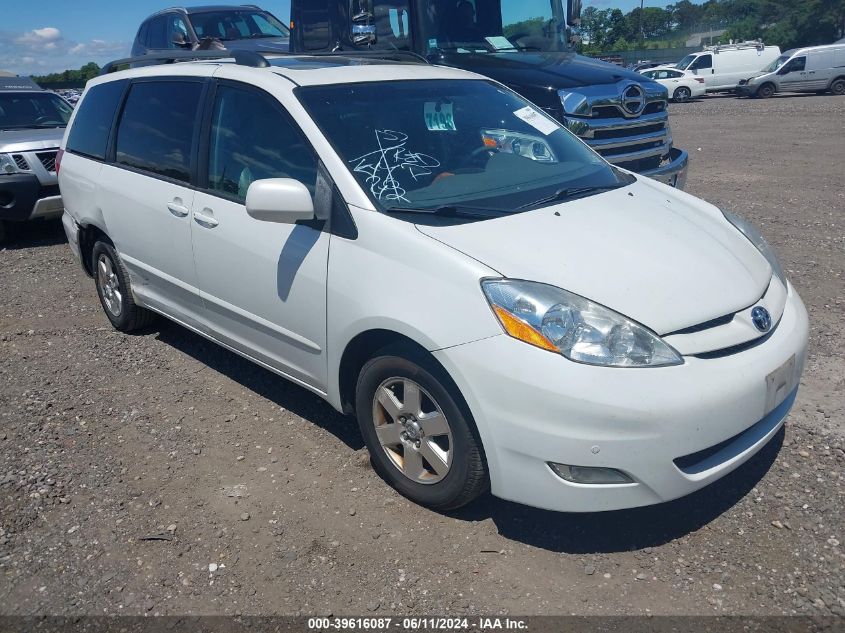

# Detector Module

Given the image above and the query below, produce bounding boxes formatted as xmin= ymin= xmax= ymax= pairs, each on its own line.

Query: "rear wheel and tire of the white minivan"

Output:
xmin=91 ymin=242 xmax=155 ymax=332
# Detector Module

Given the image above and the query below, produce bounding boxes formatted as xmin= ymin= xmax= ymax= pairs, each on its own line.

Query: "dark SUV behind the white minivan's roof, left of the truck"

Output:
xmin=132 ymin=5 xmax=290 ymax=57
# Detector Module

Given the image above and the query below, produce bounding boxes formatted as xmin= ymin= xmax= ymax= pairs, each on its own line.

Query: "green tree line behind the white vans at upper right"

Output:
xmin=579 ymin=0 xmax=845 ymax=55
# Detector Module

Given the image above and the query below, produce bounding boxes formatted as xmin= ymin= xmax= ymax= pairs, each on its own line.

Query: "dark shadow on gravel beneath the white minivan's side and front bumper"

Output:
xmin=153 ymin=321 xmax=784 ymax=554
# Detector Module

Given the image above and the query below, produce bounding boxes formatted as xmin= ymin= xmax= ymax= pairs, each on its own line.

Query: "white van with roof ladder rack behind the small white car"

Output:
xmin=677 ymin=42 xmax=780 ymax=92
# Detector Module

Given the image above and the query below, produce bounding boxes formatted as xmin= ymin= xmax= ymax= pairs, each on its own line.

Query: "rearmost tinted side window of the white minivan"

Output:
xmin=67 ymin=81 xmax=126 ymax=160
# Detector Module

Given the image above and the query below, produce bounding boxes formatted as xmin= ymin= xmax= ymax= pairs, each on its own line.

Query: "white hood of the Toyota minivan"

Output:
xmin=418 ymin=181 xmax=772 ymax=334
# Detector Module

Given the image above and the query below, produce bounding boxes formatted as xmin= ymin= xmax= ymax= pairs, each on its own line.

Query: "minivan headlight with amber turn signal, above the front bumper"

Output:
xmin=481 ymin=279 xmax=684 ymax=367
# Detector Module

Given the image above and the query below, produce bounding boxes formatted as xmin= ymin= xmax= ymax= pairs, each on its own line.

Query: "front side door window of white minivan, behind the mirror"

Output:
xmin=208 ymin=86 xmax=317 ymax=202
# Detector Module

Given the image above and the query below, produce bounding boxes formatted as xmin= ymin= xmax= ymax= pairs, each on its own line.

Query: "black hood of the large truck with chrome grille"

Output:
xmin=442 ymin=51 xmax=651 ymax=91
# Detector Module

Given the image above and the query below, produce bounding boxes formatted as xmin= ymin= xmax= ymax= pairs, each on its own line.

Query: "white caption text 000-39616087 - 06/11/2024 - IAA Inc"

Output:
xmin=308 ymin=617 xmax=528 ymax=633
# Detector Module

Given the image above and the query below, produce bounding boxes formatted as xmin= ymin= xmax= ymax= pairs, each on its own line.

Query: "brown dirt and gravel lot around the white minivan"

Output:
xmin=0 ymin=91 xmax=845 ymax=615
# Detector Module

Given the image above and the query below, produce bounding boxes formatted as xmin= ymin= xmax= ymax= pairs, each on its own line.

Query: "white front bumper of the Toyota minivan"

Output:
xmin=435 ymin=287 xmax=808 ymax=512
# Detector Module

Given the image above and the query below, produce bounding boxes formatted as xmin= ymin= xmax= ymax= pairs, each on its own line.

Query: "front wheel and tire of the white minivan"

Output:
xmin=355 ymin=345 xmax=489 ymax=511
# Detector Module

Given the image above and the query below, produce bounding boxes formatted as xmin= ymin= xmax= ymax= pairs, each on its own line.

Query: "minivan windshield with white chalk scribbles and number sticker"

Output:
xmin=296 ymin=80 xmax=632 ymax=213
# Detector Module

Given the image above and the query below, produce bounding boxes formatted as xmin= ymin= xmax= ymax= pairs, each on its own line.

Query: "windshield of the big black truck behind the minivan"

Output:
xmin=420 ymin=0 xmax=566 ymax=53
